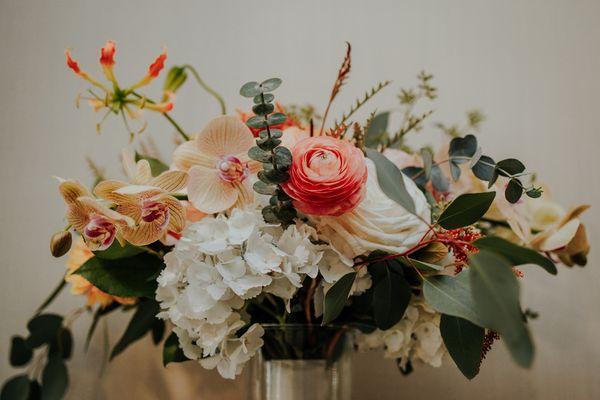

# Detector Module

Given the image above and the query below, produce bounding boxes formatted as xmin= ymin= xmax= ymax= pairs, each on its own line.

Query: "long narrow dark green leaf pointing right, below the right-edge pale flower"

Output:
xmin=473 ymin=236 xmax=557 ymax=275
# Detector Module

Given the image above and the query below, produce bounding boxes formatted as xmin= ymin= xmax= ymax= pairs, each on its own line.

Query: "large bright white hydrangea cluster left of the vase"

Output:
xmin=156 ymin=209 xmax=323 ymax=379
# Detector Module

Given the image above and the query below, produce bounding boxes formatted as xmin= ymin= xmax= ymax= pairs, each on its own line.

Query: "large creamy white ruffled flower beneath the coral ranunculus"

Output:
xmin=311 ymin=159 xmax=430 ymax=259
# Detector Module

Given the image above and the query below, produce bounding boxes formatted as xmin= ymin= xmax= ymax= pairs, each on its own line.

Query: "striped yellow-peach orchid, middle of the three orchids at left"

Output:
xmin=94 ymin=152 xmax=187 ymax=246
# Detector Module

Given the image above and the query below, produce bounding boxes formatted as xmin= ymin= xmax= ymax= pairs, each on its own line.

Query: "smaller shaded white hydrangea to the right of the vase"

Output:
xmin=357 ymin=297 xmax=447 ymax=368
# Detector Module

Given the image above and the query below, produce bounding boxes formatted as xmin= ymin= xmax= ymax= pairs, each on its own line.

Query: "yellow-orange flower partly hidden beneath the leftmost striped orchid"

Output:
xmin=65 ymin=237 xmax=135 ymax=307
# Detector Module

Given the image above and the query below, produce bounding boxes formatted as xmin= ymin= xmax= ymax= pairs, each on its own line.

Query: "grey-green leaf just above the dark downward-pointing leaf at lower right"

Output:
xmin=423 ymin=269 xmax=485 ymax=327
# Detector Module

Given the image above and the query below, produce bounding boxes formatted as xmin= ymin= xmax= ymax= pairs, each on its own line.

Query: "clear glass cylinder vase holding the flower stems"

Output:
xmin=248 ymin=324 xmax=354 ymax=400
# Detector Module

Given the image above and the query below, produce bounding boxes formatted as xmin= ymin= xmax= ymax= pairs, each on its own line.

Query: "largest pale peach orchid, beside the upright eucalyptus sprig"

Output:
xmin=173 ymin=116 xmax=260 ymax=214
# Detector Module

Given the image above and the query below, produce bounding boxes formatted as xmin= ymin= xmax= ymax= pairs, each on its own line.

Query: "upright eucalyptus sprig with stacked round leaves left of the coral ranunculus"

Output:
xmin=240 ymin=78 xmax=296 ymax=226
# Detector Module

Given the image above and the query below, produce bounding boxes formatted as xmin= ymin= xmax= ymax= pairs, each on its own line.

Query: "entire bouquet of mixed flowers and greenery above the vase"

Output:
xmin=2 ymin=41 xmax=590 ymax=399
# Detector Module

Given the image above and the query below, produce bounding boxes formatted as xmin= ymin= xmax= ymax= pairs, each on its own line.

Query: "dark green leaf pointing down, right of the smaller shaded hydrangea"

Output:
xmin=440 ymin=314 xmax=485 ymax=379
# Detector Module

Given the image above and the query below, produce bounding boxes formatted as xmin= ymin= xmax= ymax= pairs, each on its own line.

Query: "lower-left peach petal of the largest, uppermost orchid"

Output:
xmin=188 ymin=166 xmax=238 ymax=214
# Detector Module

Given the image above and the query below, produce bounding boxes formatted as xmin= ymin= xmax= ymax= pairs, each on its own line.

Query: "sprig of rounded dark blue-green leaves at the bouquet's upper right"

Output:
xmin=402 ymin=135 xmax=542 ymax=203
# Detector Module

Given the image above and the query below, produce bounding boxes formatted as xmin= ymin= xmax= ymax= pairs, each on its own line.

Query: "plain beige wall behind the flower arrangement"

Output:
xmin=0 ymin=0 xmax=600 ymax=400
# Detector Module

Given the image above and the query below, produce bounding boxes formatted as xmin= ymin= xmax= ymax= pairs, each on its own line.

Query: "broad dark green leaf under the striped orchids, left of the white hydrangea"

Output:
xmin=74 ymin=253 xmax=163 ymax=298
